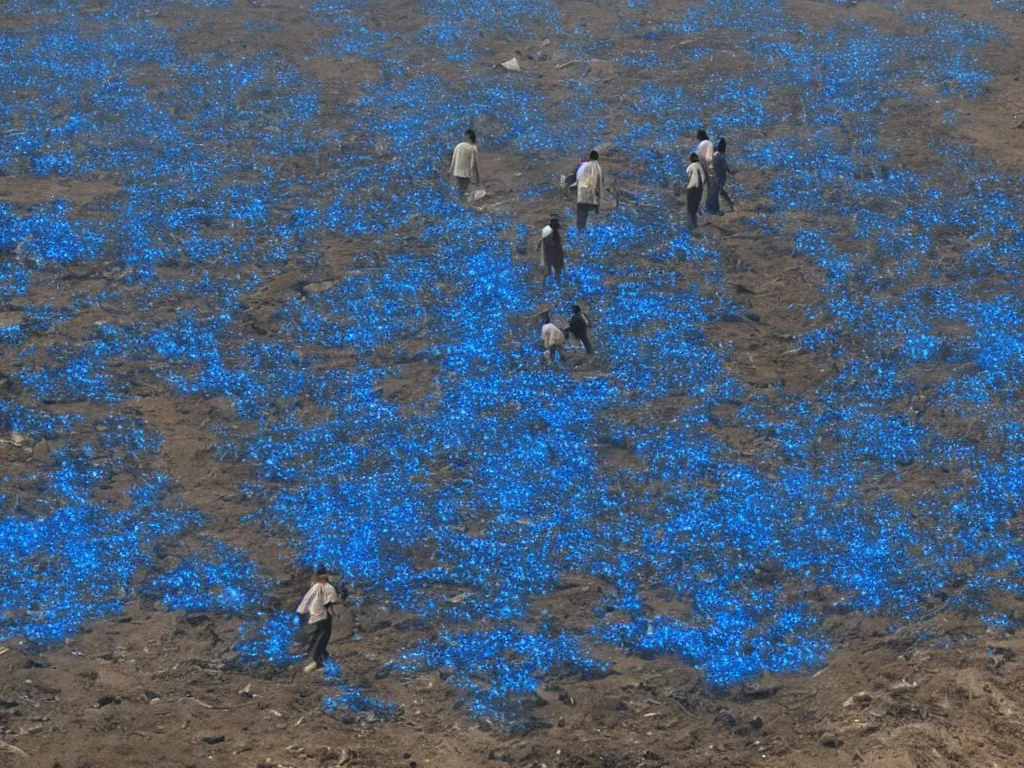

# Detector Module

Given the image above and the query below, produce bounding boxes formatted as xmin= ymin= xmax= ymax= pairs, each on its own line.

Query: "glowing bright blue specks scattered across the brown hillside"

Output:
xmin=0 ymin=0 xmax=1024 ymax=728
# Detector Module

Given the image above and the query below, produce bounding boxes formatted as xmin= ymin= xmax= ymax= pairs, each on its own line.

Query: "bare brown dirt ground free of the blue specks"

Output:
xmin=0 ymin=0 xmax=1024 ymax=768
